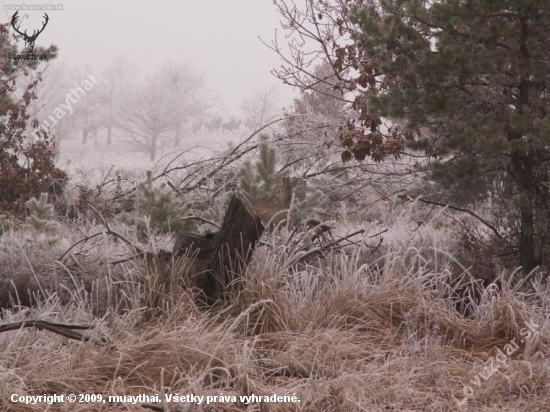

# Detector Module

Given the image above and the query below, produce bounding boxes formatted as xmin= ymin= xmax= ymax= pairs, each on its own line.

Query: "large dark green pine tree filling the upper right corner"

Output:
xmin=351 ymin=0 xmax=550 ymax=271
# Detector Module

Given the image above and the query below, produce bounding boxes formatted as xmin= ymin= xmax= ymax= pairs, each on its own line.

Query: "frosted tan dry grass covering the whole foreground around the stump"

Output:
xmin=0 ymin=214 xmax=550 ymax=412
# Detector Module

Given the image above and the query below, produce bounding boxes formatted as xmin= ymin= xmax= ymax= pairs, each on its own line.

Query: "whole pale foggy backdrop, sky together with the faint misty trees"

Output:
xmin=0 ymin=0 xmax=297 ymax=173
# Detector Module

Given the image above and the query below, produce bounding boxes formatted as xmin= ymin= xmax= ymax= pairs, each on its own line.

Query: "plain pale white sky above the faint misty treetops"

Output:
xmin=0 ymin=0 xmax=302 ymax=117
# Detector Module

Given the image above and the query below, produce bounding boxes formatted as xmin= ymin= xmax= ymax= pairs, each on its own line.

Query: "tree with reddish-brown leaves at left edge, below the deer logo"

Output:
xmin=0 ymin=19 xmax=68 ymax=211
